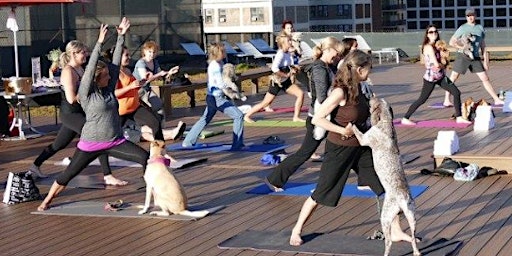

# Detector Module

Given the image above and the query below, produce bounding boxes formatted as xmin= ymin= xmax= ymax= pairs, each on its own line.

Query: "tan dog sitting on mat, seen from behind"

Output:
xmin=139 ymin=140 xmax=209 ymax=218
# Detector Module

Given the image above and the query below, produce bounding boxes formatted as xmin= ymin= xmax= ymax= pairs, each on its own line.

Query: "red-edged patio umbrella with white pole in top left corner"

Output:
xmin=0 ymin=0 xmax=90 ymax=77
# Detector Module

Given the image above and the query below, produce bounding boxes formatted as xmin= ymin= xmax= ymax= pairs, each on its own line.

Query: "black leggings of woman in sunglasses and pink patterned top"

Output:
xmin=404 ymin=76 xmax=461 ymax=119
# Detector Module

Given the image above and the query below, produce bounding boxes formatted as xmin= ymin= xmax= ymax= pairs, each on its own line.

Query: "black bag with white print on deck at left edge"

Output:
xmin=3 ymin=172 xmax=43 ymax=204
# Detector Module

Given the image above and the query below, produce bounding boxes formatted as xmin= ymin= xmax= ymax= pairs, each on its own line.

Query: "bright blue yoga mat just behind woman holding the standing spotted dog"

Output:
xmin=247 ymin=183 xmax=428 ymax=198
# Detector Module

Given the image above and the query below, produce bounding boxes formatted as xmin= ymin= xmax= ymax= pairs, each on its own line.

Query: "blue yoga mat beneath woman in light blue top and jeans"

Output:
xmin=167 ymin=143 xmax=290 ymax=153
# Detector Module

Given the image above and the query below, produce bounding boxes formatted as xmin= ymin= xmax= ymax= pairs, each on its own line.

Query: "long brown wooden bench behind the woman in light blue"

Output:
xmin=151 ymin=67 xmax=272 ymax=117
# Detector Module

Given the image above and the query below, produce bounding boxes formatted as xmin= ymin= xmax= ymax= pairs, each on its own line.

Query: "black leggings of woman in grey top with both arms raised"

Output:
xmin=56 ymin=141 xmax=149 ymax=186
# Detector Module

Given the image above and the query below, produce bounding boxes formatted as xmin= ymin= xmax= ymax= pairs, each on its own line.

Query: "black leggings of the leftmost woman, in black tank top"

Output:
xmin=34 ymin=111 xmax=112 ymax=175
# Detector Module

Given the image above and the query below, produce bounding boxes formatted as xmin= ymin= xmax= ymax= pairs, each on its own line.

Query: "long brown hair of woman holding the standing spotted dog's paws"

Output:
xmin=333 ymin=50 xmax=372 ymax=103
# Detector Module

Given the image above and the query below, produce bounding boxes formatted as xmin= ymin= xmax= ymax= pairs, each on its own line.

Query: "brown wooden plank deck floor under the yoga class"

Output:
xmin=0 ymin=62 xmax=512 ymax=255
